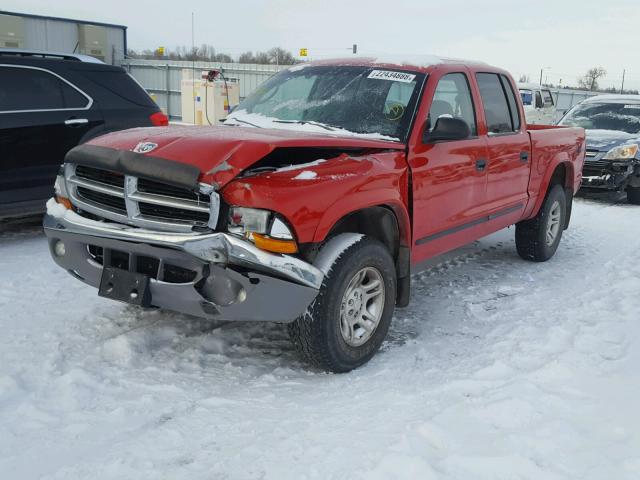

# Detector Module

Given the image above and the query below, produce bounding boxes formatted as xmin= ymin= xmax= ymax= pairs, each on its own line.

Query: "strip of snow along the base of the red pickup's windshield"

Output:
xmin=225 ymin=110 xmax=400 ymax=142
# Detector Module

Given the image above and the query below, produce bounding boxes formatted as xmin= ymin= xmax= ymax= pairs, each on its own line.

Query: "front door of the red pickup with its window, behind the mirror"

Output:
xmin=409 ymin=72 xmax=488 ymax=261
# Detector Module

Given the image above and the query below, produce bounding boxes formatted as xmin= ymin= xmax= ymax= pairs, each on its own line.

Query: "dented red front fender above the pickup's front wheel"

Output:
xmin=221 ymin=151 xmax=410 ymax=243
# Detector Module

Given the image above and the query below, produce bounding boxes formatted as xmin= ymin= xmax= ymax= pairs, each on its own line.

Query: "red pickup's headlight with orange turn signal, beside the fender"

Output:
xmin=229 ymin=207 xmax=298 ymax=253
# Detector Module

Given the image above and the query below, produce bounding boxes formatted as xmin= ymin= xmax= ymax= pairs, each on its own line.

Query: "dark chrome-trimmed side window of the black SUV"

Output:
xmin=0 ymin=67 xmax=89 ymax=112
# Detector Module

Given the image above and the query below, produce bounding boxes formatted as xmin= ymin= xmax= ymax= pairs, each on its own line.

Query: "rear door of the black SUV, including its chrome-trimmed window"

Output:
xmin=0 ymin=64 xmax=102 ymax=208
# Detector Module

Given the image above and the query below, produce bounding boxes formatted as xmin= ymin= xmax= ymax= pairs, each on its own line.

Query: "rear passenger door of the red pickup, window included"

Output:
xmin=476 ymin=73 xmax=531 ymax=213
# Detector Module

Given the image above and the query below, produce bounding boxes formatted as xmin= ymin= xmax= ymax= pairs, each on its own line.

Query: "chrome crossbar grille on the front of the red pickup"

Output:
xmin=65 ymin=164 xmax=220 ymax=232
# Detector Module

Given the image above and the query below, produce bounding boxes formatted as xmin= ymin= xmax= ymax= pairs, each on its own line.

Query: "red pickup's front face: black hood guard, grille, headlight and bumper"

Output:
xmin=44 ymin=143 xmax=324 ymax=322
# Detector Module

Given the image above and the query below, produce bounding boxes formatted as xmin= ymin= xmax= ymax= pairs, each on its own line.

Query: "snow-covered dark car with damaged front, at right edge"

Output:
xmin=559 ymin=95 xmax=640 ymax=205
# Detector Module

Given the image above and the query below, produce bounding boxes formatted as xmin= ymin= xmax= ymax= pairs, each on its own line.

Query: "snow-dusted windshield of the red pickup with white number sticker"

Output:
xmin=225 ymin=65 xmax=425 ymax=141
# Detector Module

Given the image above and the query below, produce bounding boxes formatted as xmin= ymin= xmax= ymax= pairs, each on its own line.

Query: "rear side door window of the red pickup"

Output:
xmin=476 ymin=73 xmax=520 ymax=134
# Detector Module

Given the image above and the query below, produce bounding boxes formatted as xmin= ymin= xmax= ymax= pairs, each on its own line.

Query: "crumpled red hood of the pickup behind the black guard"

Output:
xmin=88 ymin=125 xmax=405 ymax=188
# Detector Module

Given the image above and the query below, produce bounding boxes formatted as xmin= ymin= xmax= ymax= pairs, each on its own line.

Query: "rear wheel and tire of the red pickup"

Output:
xmin=516 ymin=185 xmax=567 ymax=262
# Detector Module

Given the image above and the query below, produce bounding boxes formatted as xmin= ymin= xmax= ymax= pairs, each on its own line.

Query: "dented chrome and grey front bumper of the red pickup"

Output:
xmin=44 ymin=200 xmax=324 ymax=322
